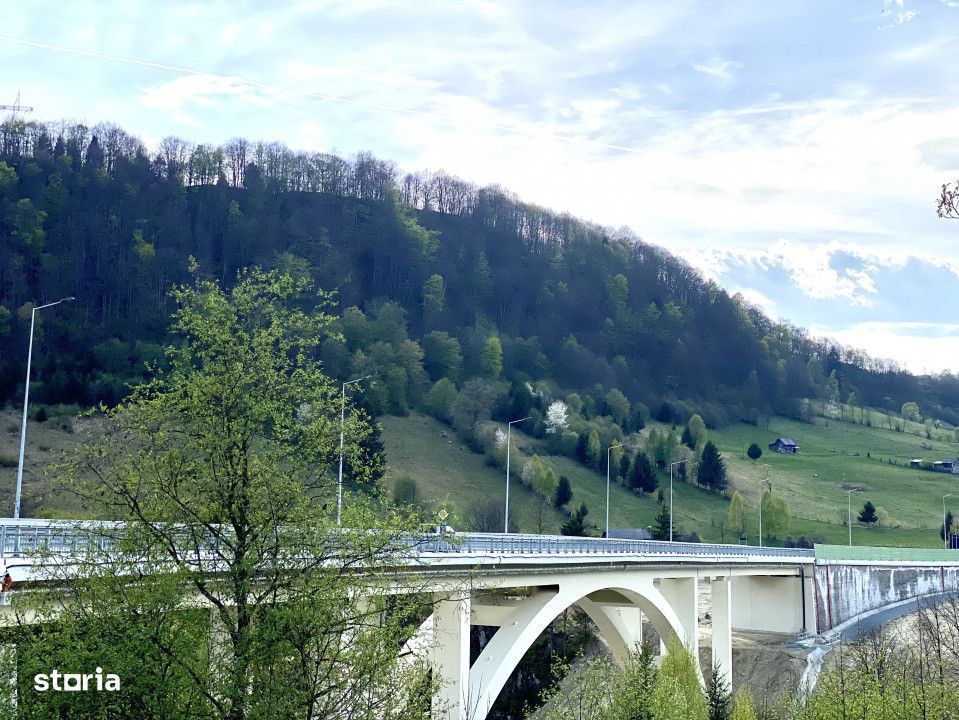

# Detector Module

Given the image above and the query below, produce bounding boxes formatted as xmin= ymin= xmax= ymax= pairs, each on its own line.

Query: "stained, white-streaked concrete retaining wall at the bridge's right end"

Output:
xmin=815 ymin=564 xmax=959 ymax=632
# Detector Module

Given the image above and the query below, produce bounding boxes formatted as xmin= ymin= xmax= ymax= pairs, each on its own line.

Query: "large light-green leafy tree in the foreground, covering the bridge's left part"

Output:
xmin=22 ymin=269 xmax=423 ymax=720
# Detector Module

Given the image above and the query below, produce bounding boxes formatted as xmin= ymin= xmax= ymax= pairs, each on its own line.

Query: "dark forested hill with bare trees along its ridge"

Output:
xmin=0 ymin=121 xmax=959 ymax=425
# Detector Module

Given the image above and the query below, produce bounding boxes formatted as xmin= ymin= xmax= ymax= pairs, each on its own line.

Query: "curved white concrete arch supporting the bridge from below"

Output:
xmin=466 ymin=577 xmax=688 ymax=720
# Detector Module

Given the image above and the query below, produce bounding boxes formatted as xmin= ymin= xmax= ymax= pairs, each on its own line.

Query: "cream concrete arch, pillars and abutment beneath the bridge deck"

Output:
xmin=406 ymin=568 xmax=815 ymax=720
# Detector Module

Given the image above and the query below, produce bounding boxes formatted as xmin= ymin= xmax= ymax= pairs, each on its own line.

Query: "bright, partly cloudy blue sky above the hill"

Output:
xmin=0 ymin=0 xmax=959 ymax=373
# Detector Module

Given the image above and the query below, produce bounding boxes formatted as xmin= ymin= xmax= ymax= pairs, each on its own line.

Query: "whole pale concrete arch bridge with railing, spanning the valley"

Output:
xmin=0 ymin=520 xmax=959 ymax=720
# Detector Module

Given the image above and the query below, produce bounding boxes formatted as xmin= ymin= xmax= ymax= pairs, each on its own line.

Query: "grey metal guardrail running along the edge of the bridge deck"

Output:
xmin=0 ymin=520 xmax=814 ymax=558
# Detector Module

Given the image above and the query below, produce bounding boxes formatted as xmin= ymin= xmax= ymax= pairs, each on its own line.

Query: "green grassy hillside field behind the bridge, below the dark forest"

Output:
xmin=383 ymin=414 xmax=959 ymax=547
